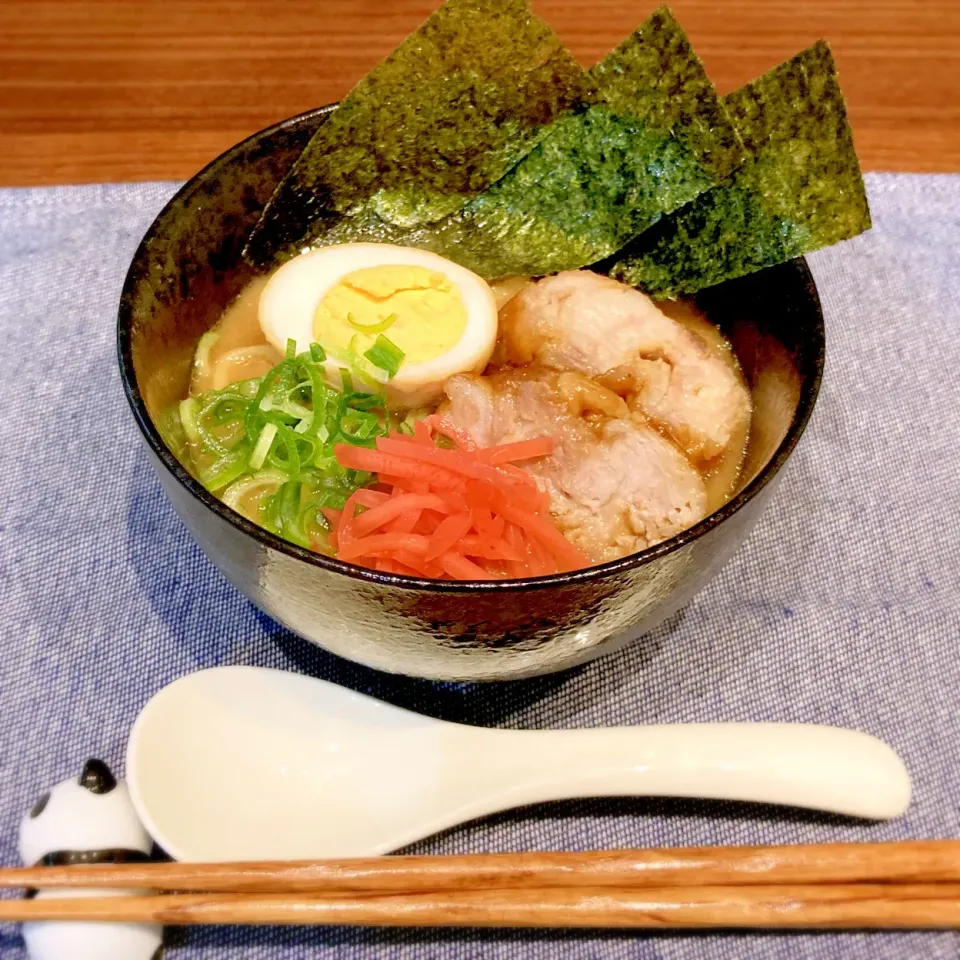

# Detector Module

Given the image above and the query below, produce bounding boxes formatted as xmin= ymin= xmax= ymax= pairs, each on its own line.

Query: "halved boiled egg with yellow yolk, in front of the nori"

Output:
xmin=259 ymin=243 xmax=497 ymax=407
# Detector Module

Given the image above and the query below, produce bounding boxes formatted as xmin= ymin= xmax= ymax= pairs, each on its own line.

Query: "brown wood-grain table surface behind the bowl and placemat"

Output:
xmin=0 ymin=0 xmax=960 ymax=186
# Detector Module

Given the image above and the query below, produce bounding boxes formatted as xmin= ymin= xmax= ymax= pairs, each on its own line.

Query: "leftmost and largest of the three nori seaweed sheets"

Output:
xmin=246 ymin=0 xmax=587 ymax=264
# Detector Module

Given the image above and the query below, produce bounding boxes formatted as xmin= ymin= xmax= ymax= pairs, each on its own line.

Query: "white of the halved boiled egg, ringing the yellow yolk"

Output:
xmin=258 ymin=243 xmax=497 ymax=407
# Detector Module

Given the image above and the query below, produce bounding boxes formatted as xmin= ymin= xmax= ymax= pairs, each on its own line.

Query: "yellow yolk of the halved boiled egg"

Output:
xmin=313 ymin=265 xmax=467 ymax=364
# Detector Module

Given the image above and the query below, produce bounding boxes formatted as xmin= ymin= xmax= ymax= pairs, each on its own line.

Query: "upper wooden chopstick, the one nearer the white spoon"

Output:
xmin=0 ymin=840 xmax=960 ymax=895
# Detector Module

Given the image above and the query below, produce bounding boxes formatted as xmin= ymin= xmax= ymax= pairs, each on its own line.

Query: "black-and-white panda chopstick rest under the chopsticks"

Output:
xmin=20 ymin=759 xmax=163 ymax=960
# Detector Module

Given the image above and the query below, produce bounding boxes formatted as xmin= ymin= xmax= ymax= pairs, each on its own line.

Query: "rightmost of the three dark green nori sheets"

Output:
xmin=602 ymin=41 xmax=870 ymax=298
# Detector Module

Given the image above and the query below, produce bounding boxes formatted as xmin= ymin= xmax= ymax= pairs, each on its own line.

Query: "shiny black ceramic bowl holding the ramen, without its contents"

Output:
xmin=118 ymin=107 xmax=824 ymax=680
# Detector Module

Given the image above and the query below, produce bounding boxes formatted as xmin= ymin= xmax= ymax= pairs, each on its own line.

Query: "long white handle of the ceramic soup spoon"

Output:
xmin=472 ymin=723 xmax=910 ymax=820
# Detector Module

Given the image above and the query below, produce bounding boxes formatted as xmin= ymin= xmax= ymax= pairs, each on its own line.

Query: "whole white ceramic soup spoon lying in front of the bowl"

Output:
xmin=127 ymin=667 xmax=910 ymax=861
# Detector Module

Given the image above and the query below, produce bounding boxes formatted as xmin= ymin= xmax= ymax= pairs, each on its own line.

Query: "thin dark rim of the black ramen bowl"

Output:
xmin=117 ymin=103 xmax=825 ymax=594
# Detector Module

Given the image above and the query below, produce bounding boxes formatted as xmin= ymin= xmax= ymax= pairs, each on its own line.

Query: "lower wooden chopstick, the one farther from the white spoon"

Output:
xmin=0 ymin=883 xmax=960 ymax=929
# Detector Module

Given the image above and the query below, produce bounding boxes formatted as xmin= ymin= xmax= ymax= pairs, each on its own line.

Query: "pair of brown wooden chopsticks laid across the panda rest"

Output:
xmin=0 ymin=840 xmax=960 ymax=929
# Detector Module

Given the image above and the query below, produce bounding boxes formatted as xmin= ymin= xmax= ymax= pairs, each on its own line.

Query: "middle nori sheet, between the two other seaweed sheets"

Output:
xmin=325 ymin=8 xmax=745 ymax=279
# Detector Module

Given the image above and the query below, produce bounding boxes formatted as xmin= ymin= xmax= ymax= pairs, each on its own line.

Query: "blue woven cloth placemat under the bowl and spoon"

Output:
xmin=0 ymin=175 xmax=960 ymax=960
